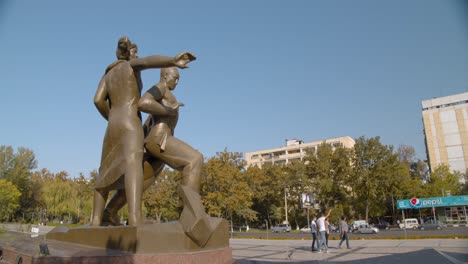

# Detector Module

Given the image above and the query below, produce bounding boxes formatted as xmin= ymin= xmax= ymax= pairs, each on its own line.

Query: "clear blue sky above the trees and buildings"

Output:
xmin=0 ymin=0 xmax=468 ymax=177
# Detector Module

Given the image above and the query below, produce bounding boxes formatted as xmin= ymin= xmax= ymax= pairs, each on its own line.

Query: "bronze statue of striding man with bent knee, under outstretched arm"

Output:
xmin=138 ymin=67 xmax=213 ymax=246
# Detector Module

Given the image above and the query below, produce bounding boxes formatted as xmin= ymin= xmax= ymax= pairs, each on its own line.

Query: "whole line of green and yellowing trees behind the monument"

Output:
xmin=0 ymin=137 xmax=468 ymax=227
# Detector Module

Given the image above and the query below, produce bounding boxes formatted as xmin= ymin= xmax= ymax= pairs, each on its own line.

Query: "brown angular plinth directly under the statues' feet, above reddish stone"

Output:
xmin=46 ymin=218 xmax=229 ymax=254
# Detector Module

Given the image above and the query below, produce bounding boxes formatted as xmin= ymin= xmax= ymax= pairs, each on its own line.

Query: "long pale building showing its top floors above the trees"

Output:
xmin=245 ymin=136 xmax=355 ymax=167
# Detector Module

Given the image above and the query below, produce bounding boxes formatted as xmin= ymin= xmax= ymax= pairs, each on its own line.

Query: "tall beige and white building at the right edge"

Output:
xmin=422 ymin=92 xmax=468 ymax=182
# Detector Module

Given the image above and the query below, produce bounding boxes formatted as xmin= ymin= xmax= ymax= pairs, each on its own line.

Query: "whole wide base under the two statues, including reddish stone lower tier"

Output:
xmin=0 ymin=218 xmax=233 ymax=264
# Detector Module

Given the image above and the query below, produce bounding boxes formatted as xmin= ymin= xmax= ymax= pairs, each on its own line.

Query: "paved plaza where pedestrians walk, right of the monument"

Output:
xmin=230 ymin=239 xmax=468 ymax=264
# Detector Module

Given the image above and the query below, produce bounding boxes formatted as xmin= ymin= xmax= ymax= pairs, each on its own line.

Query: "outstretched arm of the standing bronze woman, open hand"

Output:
xmin=129 ymin=52 xmax=196 ymax=71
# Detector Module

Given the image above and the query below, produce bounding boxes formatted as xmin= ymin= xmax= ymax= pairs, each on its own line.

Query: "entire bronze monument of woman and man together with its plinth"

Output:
xmin=41 ymin=37 xmax=232 ymax=263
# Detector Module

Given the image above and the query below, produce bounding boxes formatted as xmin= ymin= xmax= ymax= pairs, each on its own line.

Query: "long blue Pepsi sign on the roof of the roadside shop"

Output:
xmin=397 ymin=195 xmax=468 ymax=209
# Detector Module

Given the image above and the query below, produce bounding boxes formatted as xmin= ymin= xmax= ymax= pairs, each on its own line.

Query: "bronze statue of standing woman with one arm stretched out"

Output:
xmin=91 ymin=37 xmax=196 ymax=226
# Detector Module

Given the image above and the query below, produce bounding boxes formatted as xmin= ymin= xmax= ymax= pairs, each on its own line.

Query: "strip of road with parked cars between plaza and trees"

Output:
xmin=231 ymin=227 xmax=468 ymax=240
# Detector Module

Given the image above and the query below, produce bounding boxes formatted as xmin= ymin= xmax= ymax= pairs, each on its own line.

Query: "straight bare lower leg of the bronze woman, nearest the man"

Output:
xmin=125 ymin=151 xmax=143 ymax=226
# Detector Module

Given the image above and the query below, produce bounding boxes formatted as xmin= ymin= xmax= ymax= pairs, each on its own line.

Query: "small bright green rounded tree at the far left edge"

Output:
xmin=0 ymin=179 xmax=21 ymax=221
